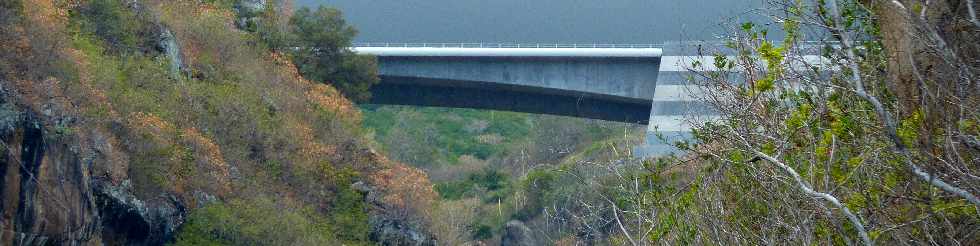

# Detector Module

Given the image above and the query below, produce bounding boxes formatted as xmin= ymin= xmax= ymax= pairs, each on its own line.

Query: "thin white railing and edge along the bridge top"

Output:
xmin=353 ymin=43 xmax=663 ymax=49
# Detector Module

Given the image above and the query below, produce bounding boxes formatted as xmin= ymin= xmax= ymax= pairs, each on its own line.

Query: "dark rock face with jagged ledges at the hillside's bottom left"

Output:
xmin=0 ymin=104 xmax=186 ymax=245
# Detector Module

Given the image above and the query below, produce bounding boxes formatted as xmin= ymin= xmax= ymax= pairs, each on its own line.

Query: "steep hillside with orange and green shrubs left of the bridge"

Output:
xmin=0 ymin=0 xmax=435 ymax=245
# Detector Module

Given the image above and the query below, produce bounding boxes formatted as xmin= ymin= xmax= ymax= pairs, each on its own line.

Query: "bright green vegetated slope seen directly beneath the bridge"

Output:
xmin=363 ymin=106 xmax=533 ymax=167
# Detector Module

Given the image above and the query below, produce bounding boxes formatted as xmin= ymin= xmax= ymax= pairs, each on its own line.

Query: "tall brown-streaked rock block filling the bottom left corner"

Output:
xmin=0 ymin=104 xmax=101 ymax=245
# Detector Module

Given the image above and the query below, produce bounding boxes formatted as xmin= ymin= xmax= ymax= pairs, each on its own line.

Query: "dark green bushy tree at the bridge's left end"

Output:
xmin=287 ymin=7 xmax=380 ymax=101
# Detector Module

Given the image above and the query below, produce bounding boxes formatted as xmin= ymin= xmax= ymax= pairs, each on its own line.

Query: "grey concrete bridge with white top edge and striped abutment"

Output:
xmin=354 ymin=44 xmax=711 ymax=153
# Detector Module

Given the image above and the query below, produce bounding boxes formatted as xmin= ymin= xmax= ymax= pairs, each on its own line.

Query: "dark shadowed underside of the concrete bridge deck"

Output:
xmin=369 ymin=75 xmax=652 ymax=124
